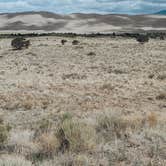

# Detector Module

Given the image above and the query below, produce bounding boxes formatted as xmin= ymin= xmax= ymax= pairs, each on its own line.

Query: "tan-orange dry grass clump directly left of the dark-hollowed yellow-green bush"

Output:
xmin=26 ymin=119 xmax=56 ymax=162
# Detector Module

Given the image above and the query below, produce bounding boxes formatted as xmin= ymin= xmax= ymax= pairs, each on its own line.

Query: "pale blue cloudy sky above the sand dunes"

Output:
xmin=0 ymin=0 xmax=166 ymax=14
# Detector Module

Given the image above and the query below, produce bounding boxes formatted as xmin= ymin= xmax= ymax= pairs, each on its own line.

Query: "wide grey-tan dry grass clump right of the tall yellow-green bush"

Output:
xmin=97 ymin=111 xmax=145 ymax=138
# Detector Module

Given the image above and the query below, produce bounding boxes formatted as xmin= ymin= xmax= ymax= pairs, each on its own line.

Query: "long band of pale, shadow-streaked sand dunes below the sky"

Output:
xmin=0 ymin=12 xmax=166 ymax=33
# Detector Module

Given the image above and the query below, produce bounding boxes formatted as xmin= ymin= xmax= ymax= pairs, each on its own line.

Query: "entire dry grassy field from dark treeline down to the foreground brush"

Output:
xmin=0 ymin=37 xmax=166 ymax=166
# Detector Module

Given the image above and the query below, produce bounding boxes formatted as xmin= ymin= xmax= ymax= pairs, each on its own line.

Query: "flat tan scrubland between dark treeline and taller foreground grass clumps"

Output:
xmin=0 ymin=37 xmax=166 ymax=165
